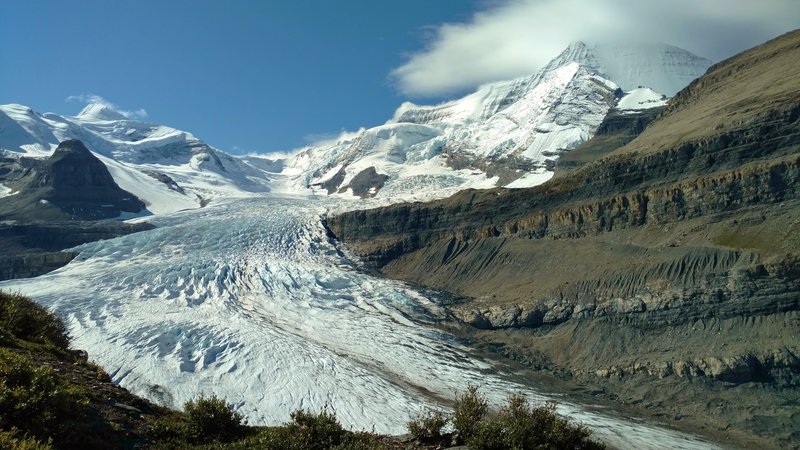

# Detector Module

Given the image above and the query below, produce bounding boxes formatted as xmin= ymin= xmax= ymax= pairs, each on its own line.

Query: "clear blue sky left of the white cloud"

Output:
xmin=0 ymin=0 xmax=482 ymax=152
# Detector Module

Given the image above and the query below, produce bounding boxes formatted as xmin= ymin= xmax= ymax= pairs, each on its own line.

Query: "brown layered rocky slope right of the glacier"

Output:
xmin=327 ymin=31 xmax=800 ymax=447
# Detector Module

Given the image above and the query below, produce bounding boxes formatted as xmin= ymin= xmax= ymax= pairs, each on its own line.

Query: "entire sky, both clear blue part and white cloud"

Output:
xmin=0 ymin=0 xmax=800 ymax=154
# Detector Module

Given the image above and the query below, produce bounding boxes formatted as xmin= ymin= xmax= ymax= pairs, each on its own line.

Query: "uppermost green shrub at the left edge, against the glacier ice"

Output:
xmin=0 ymin=292 xmax=69 ymax=350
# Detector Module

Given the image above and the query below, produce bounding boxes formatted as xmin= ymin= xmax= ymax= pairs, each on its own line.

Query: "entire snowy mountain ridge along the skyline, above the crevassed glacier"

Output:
xmin=0 ymin=42 xmax=710 ymax=214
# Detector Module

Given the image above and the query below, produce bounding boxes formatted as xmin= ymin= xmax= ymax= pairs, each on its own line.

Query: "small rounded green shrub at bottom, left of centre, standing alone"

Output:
xmin=184 ymin=395 xmax=245 ymax=441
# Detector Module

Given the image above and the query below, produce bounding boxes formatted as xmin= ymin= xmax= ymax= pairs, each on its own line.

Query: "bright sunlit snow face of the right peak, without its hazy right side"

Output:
xmin=284 ymin=63 xmax=617 ymax=200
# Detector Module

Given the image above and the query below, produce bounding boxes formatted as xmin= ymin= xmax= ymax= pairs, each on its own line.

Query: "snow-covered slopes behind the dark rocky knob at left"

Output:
xmin=0 ymin=104 xmax=269 ymax=214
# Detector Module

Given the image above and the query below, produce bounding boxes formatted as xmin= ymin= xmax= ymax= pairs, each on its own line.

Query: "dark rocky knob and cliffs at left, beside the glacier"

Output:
xmin=0 ymin=140 xmax=153 ymax=280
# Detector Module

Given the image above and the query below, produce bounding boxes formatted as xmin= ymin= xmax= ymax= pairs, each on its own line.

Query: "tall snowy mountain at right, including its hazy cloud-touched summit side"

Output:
xmin=285 ymin=43 xmax=711 ymax=199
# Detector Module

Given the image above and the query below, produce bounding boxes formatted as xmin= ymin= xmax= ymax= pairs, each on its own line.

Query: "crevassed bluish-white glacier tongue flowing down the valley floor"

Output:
xmin=0 ymin=194 xmax=714 ymax=449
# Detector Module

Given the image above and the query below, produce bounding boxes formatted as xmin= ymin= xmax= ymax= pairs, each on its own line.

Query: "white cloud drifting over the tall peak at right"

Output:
xmin=390 ymin=0 xmax=800 ymax=97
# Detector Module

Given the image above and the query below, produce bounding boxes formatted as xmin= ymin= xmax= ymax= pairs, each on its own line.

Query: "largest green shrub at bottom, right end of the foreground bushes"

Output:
xmin=467 ymin=395 xmax=605 ymax=450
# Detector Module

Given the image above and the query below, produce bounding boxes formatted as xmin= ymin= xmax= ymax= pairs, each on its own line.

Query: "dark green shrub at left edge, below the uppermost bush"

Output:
xmin=0 ymin=349 xmax=89 ymax=442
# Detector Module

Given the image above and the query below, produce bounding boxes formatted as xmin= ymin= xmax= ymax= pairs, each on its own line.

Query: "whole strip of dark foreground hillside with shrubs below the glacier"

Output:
xmin=0 ymin=292 xmax=603 ymax=450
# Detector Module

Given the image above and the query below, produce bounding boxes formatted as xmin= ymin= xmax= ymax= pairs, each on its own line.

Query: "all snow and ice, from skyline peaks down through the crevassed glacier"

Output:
xmin=0 ymin=37 xmax=716 ymax=449
